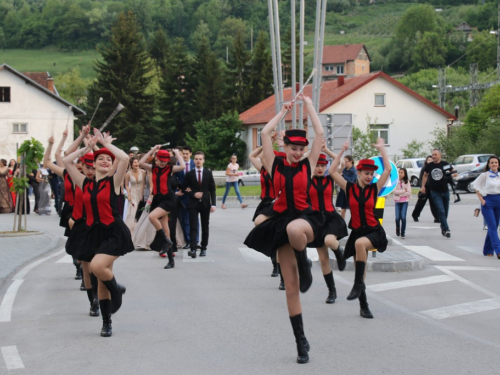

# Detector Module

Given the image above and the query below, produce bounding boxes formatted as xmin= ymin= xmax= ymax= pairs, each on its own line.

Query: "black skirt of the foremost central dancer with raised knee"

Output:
xmin=244 ymin=210 xmax=323 ymax=259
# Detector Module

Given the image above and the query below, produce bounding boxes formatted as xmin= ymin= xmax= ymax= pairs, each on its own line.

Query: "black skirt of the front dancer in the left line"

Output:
xmin=77 ymin=218 xmax=134 ymax=262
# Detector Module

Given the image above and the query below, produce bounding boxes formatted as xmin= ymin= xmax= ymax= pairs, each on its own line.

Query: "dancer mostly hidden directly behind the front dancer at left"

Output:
xmin=66 ymin=152 xmax=99 ymax=316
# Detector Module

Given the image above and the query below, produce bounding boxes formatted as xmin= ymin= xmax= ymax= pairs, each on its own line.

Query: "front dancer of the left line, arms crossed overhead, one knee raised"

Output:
xmin=64 ymin=129 xmax=134 ymax=337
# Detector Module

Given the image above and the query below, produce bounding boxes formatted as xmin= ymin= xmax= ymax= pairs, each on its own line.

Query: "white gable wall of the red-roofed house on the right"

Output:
xmin=322 ymin=78 xmax=447 ymax=159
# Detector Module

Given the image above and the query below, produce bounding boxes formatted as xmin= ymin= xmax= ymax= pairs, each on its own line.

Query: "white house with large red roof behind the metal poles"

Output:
xmin=240 ymin=72 xmax=456 ymax=158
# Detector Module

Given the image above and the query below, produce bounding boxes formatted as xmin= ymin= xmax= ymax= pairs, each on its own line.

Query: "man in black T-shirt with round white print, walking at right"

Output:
xmin=420 ymin=149 xmax=456 ymax=238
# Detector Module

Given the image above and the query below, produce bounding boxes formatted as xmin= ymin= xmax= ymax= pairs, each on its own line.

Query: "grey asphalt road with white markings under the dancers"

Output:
xmin=0 ymin=200 xmax=500 ymax=375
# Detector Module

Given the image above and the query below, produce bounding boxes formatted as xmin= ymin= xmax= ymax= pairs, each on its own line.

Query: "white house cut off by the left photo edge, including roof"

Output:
xmin=0 ymin=64 xmax=85 ymax=160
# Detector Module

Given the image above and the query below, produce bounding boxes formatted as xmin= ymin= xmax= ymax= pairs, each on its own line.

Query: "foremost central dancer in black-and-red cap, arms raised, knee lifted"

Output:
xmin=245 ymin=97 xmax=323 ymax=363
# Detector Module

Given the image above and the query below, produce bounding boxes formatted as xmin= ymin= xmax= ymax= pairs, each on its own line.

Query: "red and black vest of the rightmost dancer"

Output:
xmin=345 ymin=182 xmax=380 ymax=229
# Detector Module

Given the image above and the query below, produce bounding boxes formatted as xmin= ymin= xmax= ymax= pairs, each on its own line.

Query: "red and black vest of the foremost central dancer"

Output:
xmin=272 ymin=158 xmax=311 ymax=213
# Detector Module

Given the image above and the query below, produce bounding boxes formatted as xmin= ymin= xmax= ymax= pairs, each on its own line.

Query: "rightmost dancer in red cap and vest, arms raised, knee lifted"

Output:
xmin=331 ymin=138 xmax=391 ymax=319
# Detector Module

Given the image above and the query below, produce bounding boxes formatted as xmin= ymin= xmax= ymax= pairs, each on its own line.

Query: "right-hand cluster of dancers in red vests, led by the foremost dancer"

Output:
xmin=245 ymin=97 xmax=391 ymax=363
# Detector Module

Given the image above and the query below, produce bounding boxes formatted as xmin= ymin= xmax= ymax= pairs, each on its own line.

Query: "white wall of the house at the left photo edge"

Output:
xmin=0 ymin=69 xmax=74 ymax=160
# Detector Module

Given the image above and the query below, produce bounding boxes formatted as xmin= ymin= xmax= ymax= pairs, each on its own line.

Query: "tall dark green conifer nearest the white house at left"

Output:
xmin=88 ymin=12 xmax=156 ymax=149
